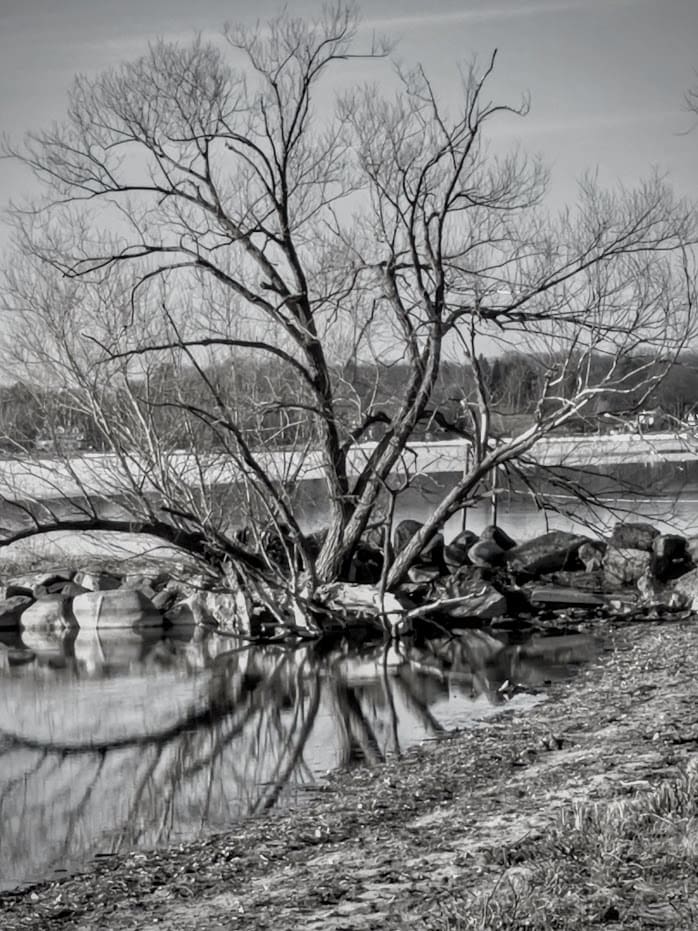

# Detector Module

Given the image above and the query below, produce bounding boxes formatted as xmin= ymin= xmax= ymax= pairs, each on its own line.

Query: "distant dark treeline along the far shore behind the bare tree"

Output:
xmin=0 ymin=352 xmax=698 ymax=450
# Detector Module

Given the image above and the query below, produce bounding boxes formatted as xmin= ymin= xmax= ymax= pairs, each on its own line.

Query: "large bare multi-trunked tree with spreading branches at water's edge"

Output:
xmin=4 ymin=5 xmax=693 ymax=628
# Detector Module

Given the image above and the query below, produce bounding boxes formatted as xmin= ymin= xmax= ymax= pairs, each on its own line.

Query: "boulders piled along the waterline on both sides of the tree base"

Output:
xmin=0 ymin=521 xmax=698 ymax=636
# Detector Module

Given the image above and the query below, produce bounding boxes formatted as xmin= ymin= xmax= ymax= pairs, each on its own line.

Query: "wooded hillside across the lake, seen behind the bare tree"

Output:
xmin=0 ymin=351 xmax=698 ymax=454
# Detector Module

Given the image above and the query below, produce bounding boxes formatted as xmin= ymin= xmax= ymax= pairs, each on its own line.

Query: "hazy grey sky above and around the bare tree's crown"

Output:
xmin=0 ymin=0 xmax=698 ymax=226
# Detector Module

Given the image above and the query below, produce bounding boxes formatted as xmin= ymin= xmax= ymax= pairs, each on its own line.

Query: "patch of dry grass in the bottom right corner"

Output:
xmin=429 ymin=767 xmax=698 ymax=931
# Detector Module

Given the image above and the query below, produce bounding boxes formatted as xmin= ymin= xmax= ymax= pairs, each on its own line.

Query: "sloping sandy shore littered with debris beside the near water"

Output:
xmin=0 ymin=617 xmax=698 ymax=931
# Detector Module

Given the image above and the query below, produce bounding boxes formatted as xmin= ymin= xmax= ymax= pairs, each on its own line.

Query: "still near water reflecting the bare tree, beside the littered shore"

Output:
xmin=0 ymin=627 xmax=596 ymax=888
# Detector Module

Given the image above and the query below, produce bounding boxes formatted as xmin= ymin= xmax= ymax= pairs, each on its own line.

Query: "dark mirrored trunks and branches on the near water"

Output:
xmin=0 ymin=631 xmax=600 ymax=892
